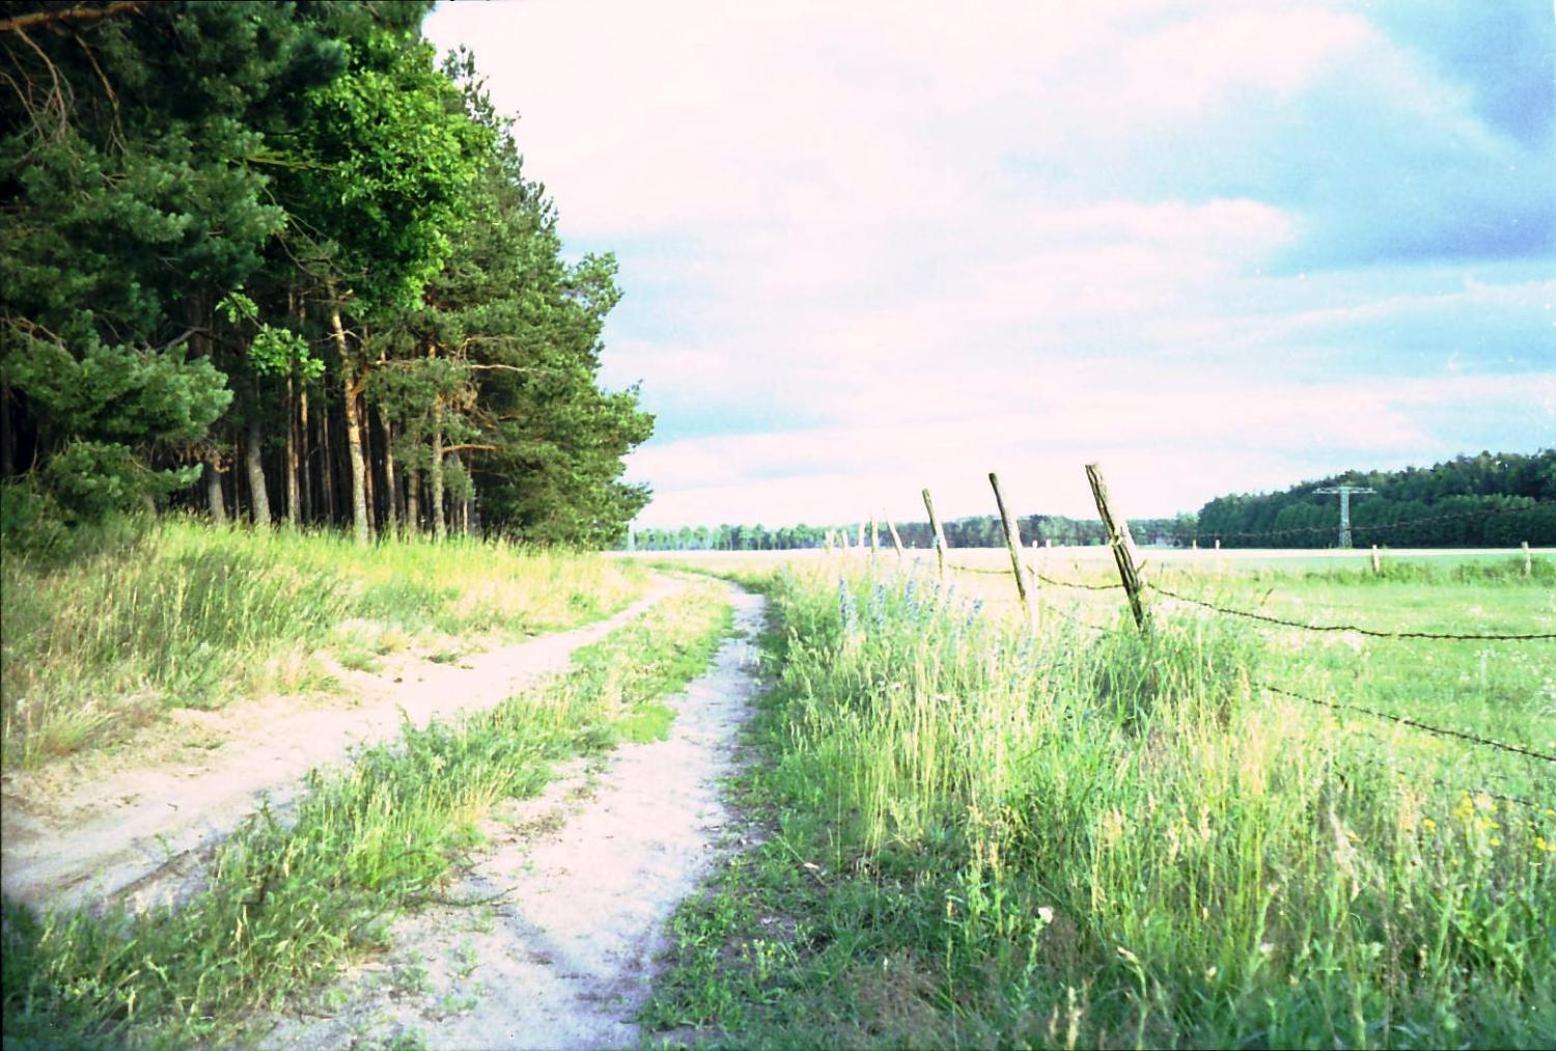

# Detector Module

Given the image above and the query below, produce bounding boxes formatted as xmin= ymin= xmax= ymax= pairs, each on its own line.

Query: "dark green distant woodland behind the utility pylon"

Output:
xmin=1198 ymin=448 xmax=1556 ymax=548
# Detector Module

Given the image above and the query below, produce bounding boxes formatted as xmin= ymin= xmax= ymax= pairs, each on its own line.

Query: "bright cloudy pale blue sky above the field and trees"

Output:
xmin=425 ymin=0 xmax=1556 ymax=526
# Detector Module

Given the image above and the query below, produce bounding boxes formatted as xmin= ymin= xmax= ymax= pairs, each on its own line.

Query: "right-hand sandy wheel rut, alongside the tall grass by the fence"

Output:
xmin=265 ymin=587 xmax=764 ymax=1051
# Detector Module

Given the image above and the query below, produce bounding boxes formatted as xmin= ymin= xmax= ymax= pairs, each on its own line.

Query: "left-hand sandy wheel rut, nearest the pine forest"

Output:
xmin=0 ymin=578 xmax=683 ymax=908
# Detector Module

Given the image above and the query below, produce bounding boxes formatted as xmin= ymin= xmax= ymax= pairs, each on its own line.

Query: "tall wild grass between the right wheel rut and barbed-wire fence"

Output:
xmin=644 ymin=573 xmax=1556 ymax=1048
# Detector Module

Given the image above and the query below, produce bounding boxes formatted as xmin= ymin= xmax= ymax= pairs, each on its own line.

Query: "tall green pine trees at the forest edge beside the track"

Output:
xmin=0 ymin=0 xmax=652 ymax=545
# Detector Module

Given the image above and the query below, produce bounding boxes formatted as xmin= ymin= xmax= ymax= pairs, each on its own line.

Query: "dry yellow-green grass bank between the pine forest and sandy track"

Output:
xmin=0 ymin=520 xmax=646 ymax=769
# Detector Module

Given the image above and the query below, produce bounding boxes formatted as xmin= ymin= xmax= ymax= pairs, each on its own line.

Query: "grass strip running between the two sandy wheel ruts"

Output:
xmin=3 ymin=585 xmax=731 ymax=1046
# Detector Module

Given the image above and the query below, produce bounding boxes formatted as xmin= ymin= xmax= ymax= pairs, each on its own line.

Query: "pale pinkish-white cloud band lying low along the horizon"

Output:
xmin=619 ymin=375 xmax=1556 ymax=526
